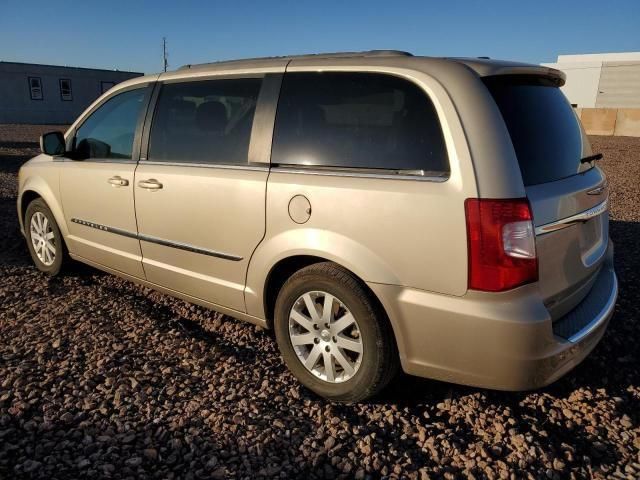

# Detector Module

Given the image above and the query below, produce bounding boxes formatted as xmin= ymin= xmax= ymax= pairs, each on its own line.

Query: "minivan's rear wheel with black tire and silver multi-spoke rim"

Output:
xmin=274 ymin=262 xmax=399 ymax=403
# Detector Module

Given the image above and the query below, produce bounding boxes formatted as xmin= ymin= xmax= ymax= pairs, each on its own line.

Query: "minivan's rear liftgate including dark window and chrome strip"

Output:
xmin=484 ymin=75 xmax=609 ymax=318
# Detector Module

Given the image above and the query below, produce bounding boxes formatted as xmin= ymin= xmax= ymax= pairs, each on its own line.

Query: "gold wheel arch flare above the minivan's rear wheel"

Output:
xmin=245 ymin=228 xmax=400 ymax=318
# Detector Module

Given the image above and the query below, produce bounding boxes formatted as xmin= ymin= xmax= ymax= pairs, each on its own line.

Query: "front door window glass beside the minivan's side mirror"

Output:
xmin=75 ymin=88 xmax=146 ymax=159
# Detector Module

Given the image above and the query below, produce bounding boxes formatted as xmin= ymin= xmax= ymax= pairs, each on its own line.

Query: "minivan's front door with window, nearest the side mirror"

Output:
xmin=60 ymin=86 xmax=148 ymax=278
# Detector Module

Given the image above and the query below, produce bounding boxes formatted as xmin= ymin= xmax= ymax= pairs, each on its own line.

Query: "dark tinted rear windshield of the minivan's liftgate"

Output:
xmin=484 ymin=76 xmax=590 ymax=186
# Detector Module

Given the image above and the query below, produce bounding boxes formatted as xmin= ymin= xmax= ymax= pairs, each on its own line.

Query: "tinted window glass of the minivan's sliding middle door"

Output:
xmin=148 ymin=78 xmax=262 ymax=165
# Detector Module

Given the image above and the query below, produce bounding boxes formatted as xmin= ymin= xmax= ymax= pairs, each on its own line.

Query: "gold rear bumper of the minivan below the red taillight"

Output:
xmin=369 ymin=244 xmax=618 ymax=391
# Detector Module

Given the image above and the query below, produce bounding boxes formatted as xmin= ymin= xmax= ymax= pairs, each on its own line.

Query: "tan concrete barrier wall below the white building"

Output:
xmin=576 ymin=108 xmax=640 ymax=137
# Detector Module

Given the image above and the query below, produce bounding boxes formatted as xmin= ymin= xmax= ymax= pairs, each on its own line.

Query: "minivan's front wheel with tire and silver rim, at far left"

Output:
xmin=24 ymin=198 xmax=68 ymax=277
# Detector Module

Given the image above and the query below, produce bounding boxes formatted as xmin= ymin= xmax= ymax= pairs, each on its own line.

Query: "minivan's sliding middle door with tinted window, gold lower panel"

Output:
xmin=134 ymin=74 xmax=269 ymax=311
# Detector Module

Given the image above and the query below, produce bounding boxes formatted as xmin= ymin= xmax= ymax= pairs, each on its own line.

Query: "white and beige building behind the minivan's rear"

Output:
xmin=543 ymin=52 xmax=640 ymax=108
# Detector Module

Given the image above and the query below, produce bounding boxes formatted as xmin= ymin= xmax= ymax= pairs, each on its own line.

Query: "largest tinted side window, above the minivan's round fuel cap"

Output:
xmin=271 ymin=72 xmax=449 ymax=176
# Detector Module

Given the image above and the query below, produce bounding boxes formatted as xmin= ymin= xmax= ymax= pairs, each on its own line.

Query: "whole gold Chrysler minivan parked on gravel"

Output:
xmin=18 ymin=51 xmax=617 ymax=402
